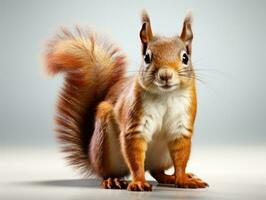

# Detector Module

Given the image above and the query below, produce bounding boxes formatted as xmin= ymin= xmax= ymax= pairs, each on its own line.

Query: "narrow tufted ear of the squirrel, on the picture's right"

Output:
xmin=180 ymin=12 xmax=193 ymax=54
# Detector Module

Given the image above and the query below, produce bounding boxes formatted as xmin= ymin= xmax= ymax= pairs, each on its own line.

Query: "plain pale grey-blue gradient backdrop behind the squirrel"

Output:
xmin=0 ymin=0 xmax=266 ymax=146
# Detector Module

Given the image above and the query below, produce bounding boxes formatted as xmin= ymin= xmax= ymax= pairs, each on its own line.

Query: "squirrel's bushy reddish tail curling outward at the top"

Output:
xmin=45 ymin=28 xmax=126 ymax=173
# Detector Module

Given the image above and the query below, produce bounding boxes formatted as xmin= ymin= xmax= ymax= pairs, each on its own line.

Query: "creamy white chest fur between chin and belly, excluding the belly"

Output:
xmin=140 ymin=91 xmax=191 ymax=141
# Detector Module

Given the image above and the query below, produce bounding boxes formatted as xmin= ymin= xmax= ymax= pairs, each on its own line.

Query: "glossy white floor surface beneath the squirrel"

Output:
xmin=0 ymin=145 xmax=266 ymax=200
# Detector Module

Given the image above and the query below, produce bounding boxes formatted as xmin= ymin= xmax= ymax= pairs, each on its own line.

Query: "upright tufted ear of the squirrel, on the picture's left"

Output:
xmin=139 ymin=10 xmax=153 ymax=52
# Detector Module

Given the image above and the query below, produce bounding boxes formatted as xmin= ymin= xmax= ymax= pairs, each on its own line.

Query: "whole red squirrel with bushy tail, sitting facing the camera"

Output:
xmin=45 ymin=11 xmax=208 ymax=191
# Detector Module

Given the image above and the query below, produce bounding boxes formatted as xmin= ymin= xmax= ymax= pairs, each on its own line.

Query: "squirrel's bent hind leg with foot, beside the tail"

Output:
xmin=89 ymin=101 xmax=128 ymax=180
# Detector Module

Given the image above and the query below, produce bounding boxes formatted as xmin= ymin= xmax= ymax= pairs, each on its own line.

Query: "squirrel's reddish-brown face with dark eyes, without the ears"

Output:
xmin=139 ymin=37 xmax=194 ymax=93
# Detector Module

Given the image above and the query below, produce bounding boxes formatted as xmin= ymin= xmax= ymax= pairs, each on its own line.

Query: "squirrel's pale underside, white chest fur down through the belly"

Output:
xmin=139 ymin=91 xmax=191 ymax=171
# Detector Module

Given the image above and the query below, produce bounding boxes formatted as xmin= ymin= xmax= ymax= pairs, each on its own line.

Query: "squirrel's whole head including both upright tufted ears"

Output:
xmin=139 ymin=11 xmax=194 ymax=93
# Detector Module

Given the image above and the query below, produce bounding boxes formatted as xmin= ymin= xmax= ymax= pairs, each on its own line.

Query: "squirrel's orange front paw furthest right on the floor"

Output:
xmin=175 ymin=173 xmax=209 ymax=188
